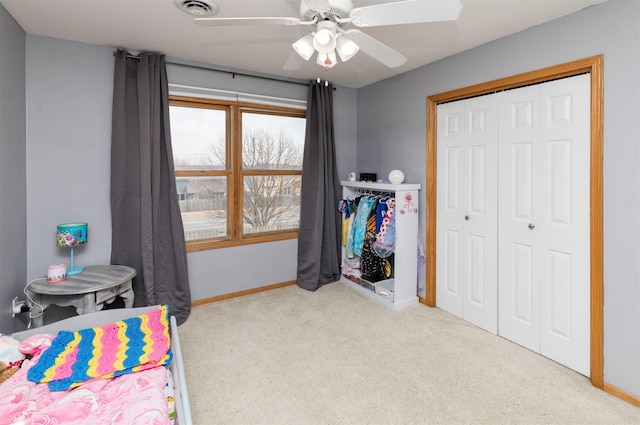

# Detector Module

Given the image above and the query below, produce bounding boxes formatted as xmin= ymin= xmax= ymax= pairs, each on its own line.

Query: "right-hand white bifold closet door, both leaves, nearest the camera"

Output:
xmin=499 ymin=74 xmax=590 ymax=376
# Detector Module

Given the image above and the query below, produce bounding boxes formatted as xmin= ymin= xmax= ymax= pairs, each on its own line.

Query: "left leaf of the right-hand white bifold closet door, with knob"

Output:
xmin=498 ymin=86 xmax=541 ymax=351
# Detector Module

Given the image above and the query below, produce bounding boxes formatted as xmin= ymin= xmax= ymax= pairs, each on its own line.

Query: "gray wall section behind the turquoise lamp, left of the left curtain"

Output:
xmin=26 ymin=35 xmax=114 ymax=280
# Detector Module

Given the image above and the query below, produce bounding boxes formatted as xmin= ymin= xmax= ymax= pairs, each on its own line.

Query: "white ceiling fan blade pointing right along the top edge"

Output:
xmin=349 ymin=0 xmax=462 ymax=27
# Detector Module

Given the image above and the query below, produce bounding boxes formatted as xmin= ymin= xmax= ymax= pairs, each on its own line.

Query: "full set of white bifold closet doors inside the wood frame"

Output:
xmin=436 ymin=74 xmax=590 ymax=376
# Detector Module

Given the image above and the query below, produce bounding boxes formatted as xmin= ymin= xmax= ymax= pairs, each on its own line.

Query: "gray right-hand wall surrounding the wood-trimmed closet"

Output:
xmin=358 ymin=0 xmax=640 ymax=396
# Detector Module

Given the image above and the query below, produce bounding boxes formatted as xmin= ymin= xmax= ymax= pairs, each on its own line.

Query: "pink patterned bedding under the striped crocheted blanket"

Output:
xmin=0 ymin=335 xmax=171 ymax=425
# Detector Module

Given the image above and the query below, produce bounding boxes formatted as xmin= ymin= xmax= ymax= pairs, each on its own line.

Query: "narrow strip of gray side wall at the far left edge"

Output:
xmin=0 ymin=5 xmax=27 ymax=333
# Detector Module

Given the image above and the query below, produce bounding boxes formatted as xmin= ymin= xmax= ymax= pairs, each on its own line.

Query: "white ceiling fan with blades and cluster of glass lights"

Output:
xmin=195 ymin=0 xmax=462 ymax=68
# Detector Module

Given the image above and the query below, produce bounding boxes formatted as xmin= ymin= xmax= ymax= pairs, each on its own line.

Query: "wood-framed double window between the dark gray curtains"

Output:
xmin=169 ymin=96 xmax=306 ymax=251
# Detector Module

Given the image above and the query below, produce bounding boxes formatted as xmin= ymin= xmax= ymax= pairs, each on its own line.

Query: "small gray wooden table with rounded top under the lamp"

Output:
xmin=27 ymin=266 xmax=136 ymax=327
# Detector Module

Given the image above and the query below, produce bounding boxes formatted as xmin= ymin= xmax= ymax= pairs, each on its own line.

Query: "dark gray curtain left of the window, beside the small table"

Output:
xmin=111 ymin=50 xmax=191 ymax=323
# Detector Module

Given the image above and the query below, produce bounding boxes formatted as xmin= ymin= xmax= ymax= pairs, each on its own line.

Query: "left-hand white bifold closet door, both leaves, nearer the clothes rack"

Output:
xmin=436 ymin=95 xmax=498 ymax=333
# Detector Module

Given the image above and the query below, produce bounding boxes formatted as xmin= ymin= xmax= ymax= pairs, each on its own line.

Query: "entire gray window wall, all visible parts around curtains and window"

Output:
xmin=15 ymin=35 xmax=357 ymax=314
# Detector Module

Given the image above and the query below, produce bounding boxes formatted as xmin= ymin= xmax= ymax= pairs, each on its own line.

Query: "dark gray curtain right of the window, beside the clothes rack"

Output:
xmin=297 ymin=81 xmax=341 ymax=291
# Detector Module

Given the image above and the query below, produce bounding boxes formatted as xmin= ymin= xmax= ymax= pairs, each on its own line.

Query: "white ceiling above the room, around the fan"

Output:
xmin=0 ymin=0 xmax=605 ymax=88
